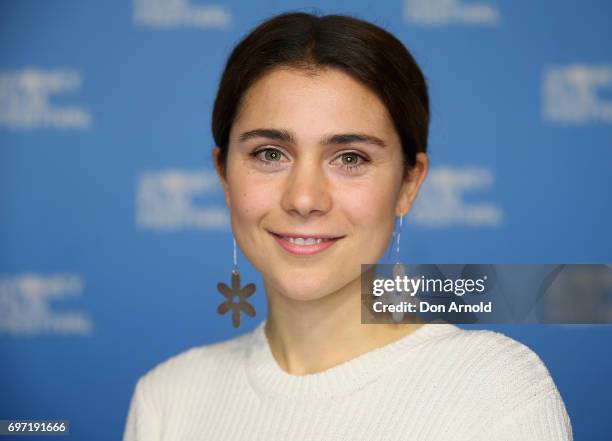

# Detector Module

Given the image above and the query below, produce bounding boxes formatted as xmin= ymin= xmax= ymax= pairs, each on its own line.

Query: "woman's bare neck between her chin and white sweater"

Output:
xmin=264 ymin=268 xmax=421 ymax=375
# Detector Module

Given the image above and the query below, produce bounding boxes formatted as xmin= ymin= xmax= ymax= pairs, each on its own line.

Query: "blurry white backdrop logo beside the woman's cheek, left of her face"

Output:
xmin=136 ymin=170 xmax=230 ymax=231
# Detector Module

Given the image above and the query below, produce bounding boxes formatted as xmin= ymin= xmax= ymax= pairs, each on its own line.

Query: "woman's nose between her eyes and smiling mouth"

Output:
xmin=281 ymin=158 xmax=332 ymax=218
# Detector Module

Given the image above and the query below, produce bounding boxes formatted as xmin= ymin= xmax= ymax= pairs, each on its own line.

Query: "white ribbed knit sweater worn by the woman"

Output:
xmin=123 ymin=321 xmax=572 ymax=441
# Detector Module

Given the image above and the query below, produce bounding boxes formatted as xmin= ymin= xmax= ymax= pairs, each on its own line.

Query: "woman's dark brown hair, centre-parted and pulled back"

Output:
xmin=212 ymin=12 xmax=429 ymax=175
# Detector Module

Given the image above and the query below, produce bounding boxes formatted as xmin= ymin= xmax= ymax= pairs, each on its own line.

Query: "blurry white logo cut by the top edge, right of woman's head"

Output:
xmin=404 ymin=0 xmax=500 ymax=26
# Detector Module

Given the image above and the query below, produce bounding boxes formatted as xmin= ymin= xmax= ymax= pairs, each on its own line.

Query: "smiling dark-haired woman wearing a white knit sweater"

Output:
xmin=124 ymin=13 xmax=572 ymax=441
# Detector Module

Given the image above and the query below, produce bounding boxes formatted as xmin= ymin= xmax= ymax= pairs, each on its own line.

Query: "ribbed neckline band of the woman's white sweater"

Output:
xmin=244 ymin=319 xmax=460 ymax=399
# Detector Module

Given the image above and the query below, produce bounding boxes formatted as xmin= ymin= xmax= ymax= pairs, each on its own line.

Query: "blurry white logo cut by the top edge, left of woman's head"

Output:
xmin=134 ymin=0 xmax=232 ymax=29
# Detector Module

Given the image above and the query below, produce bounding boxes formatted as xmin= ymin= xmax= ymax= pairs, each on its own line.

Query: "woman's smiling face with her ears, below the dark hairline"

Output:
xmin=215 ymin=69 xmax=427 ymax=300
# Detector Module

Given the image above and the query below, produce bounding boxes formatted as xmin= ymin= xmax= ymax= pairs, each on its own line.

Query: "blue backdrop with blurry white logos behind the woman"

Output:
xmin=0 ymin=0 xmax=612 ymax=440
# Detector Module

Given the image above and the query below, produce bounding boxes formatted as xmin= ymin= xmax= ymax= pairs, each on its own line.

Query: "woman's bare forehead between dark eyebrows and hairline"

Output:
xmin=232 ymin=68 xmax=399 ymax=142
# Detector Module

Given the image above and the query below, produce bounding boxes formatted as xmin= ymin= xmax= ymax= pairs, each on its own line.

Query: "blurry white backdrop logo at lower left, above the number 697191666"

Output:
xmin=0 ymin=273 xmax=93 ymax=336
